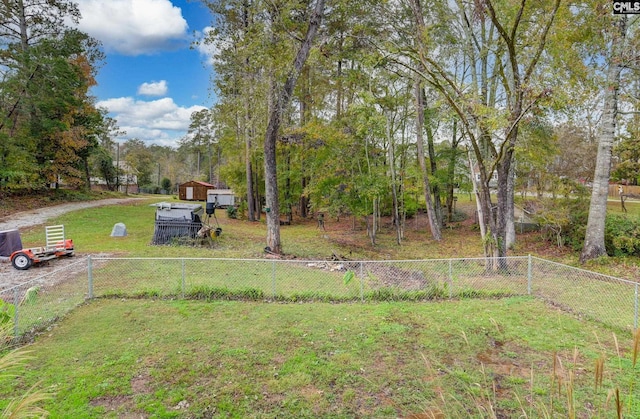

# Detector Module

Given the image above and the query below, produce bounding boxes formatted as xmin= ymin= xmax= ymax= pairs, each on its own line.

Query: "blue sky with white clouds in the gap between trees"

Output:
xmin=76 ymin=0 xmax=214 ymax=147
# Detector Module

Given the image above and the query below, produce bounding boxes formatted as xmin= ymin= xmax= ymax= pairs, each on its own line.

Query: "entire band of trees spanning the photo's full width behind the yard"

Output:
xmin=0 ymin=0 xmax=640 ymax=263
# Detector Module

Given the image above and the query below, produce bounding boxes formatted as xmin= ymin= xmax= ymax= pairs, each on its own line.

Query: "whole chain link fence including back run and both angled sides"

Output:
xmin=0 ymin=256 xmax=639 ymax=336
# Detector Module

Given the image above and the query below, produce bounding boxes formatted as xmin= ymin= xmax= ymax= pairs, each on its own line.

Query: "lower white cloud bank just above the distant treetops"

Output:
xmin=97 ymin=97 xmax=205 ymax=146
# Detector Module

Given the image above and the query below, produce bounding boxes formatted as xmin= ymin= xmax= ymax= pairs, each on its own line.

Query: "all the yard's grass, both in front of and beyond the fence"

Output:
xmin=0 ymin=197 xmax=640 ymax=418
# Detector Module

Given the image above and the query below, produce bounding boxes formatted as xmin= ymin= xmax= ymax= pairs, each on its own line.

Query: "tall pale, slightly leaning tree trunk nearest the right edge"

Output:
xmin=580 ymin=15 xmax=627 ymax=263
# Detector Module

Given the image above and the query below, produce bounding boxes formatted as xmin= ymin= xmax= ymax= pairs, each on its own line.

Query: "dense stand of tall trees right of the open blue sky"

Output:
xmin=196 ymin=0 xmax=638 ymax=260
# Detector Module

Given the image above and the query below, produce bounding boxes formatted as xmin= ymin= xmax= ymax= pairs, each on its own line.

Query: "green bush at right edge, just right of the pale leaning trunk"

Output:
xmin=604 ymin=214 xmax=640 ymax=256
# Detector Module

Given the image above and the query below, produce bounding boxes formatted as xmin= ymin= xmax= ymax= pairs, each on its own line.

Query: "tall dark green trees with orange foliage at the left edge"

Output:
xmin=0 ymin=0 xmax=107 ymax=190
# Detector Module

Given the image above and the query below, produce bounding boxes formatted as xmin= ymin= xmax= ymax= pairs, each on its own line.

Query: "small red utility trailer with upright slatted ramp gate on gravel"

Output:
xmin=10 ymin=225 xmax=74 ymax=271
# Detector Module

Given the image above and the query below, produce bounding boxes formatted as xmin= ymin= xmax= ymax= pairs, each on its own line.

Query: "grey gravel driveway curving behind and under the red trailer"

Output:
xmin=0 ymin=198 xmax=144 ymax=289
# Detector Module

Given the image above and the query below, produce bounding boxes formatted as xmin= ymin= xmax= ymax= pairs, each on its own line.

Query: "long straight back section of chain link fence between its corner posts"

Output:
xmin=90 ymin=257 xmax=529 ymax=302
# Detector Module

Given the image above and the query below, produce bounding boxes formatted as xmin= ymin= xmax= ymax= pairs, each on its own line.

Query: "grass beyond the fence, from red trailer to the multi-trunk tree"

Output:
xmin=15 ymin=197 xmax=482 ymax=260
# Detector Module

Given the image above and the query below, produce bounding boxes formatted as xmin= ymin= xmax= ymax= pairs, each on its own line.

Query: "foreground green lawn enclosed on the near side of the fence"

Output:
xmin=5 ymin=298 xmax=640 ymax=418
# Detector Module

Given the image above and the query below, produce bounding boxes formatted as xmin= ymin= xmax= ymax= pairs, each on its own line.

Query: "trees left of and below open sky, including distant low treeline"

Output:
xmin=0 ymin=0 xmax=220 ymax=194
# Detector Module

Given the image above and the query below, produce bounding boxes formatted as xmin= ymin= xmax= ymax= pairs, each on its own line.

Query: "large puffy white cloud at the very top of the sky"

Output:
xmin=78 ymin=0 xmax=189 ymax=55
